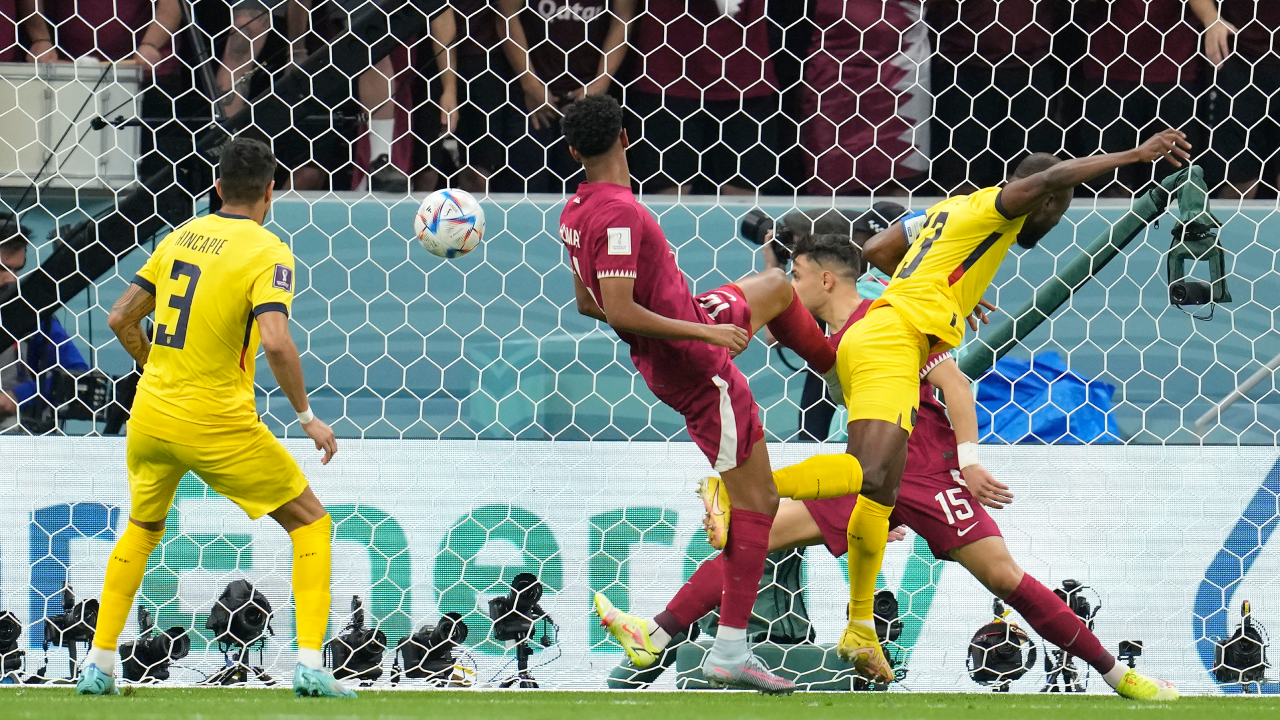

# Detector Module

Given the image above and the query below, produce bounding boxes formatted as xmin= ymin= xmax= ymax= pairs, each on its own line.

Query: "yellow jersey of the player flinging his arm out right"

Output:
xmin=873 ymin=187 xmax=1025 ymax=352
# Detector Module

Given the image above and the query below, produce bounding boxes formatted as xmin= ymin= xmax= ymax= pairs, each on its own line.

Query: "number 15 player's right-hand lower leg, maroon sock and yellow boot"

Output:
xmin=951 ymin=537 xmax=1179 ymax=701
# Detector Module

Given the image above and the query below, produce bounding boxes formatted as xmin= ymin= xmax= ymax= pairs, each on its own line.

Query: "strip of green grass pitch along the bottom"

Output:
xmin=0 ymin=688 xmax=1280 ymax=720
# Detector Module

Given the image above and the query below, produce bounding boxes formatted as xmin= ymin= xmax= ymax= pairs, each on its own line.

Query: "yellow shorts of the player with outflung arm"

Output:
xmin=836 ymin=305 xmax=929 ymax=433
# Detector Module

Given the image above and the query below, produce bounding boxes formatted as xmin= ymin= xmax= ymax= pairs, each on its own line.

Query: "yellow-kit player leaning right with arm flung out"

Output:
xmin=836 ymin=129 xmax=1190 ymax=682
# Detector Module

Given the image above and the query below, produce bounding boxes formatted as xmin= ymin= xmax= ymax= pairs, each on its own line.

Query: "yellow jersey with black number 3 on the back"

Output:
xmin=129 ymin=213 xmax=293 ymax=446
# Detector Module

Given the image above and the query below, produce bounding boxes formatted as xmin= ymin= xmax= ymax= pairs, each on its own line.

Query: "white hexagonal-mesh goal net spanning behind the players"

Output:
xmin=0 ymin=0 xmax=1280 ymax=693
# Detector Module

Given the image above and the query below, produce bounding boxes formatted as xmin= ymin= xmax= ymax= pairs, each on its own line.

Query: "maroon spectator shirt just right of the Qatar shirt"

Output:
xmin=631 ymin=0 xmax=778 ymax=100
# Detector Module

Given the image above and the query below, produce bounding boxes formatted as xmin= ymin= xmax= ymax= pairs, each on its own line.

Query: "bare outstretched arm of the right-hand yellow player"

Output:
xmin=996 ymin=129 xmax=1192 ymax=218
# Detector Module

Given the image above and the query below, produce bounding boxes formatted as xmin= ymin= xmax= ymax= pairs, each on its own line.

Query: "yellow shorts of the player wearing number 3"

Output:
xmin=125 ymin=423 xmax=307 ymax=523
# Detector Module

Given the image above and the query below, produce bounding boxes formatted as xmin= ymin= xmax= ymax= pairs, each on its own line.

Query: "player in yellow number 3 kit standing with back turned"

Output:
xmin=77 ymin=140 xmax=356 ymax=697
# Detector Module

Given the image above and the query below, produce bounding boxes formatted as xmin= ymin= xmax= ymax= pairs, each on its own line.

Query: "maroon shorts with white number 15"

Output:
xmin=804 ymin=474 xmax=1001 ymax=560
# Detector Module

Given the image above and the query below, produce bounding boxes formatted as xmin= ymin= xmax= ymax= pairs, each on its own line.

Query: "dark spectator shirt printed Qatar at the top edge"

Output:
xmin=520 ymin=0 xmax=613 ymax=97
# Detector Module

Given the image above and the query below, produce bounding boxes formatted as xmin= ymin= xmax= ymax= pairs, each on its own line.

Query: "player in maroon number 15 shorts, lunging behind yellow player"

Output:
xmin=599 ymin=234 xmax=1178 ymax=700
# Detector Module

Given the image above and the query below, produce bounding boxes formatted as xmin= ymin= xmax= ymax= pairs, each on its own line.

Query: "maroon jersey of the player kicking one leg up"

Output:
xmin=559 ymin=182 xmax=731 ymax=389
